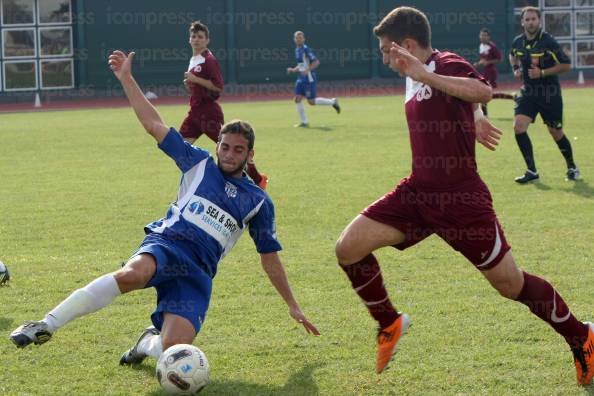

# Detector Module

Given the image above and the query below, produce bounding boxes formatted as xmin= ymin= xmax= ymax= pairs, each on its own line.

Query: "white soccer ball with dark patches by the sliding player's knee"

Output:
xmin=157 ymin=344 xmax=210 ymax=395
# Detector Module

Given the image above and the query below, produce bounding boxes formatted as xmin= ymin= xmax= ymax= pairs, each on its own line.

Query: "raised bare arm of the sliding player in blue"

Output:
xmin=109 ymin=51 xmax=169 ymax=143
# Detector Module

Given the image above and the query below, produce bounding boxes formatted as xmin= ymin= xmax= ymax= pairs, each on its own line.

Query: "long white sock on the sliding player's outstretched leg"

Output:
xmin=43 ymin=274 xmax=122 ymax=333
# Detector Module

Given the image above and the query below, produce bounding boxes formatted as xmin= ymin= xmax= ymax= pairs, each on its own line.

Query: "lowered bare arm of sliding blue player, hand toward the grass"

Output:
xmin=260 ymin=252 xmax=320 ymax=335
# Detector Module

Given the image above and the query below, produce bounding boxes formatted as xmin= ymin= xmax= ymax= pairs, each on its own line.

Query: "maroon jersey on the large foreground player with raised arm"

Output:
xmin=405 ymin=51 xmax=486 ymax=190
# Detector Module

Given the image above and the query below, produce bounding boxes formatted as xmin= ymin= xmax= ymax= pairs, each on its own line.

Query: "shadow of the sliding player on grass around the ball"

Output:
xmin=143 ymin=364 xmax=321 ymax=396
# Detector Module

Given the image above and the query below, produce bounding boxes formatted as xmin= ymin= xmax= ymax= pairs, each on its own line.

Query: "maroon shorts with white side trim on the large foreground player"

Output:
xmin=362 ymin=179 xmax=510 ymax=270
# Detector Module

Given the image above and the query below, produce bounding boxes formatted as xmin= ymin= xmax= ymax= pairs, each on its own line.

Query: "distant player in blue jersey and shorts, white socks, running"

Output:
xmin=287 ymin=30 xmax=340 ymax=127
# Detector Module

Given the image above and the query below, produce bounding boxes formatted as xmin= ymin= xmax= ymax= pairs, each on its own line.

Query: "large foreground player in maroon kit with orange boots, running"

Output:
xmin=336 ymin=7 xmax=594 ymax=384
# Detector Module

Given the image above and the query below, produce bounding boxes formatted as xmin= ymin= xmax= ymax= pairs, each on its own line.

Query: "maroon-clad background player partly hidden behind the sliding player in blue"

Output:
xmin=179 ymin=21 xmax=268 ymax=190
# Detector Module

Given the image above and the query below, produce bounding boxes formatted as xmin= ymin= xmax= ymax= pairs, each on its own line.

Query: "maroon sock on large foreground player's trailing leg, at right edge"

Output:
xmin=516 ymin=272 xmax=588 ymax=347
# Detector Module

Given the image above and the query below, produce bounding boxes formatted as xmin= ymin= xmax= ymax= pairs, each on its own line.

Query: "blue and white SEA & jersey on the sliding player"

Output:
xmin=145 ymin=128 xmax=281 ymax=277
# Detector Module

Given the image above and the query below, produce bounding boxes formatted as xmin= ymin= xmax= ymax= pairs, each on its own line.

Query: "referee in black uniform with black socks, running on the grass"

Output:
xmin=509 ymin=7 xmax=580 ymax=184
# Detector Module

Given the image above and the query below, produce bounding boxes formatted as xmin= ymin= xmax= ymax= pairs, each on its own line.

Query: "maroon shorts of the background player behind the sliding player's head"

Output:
xmin=179 ymin=102 xmax=225 ymax=142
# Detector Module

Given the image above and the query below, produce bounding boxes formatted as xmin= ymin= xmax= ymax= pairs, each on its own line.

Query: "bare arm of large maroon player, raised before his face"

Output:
xmin=390 ymin=43 xmax=493 ymax=103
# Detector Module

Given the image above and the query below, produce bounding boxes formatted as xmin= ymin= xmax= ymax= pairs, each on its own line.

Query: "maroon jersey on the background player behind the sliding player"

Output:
xmin=188 ymin=49 xmax=224 ymax=107
